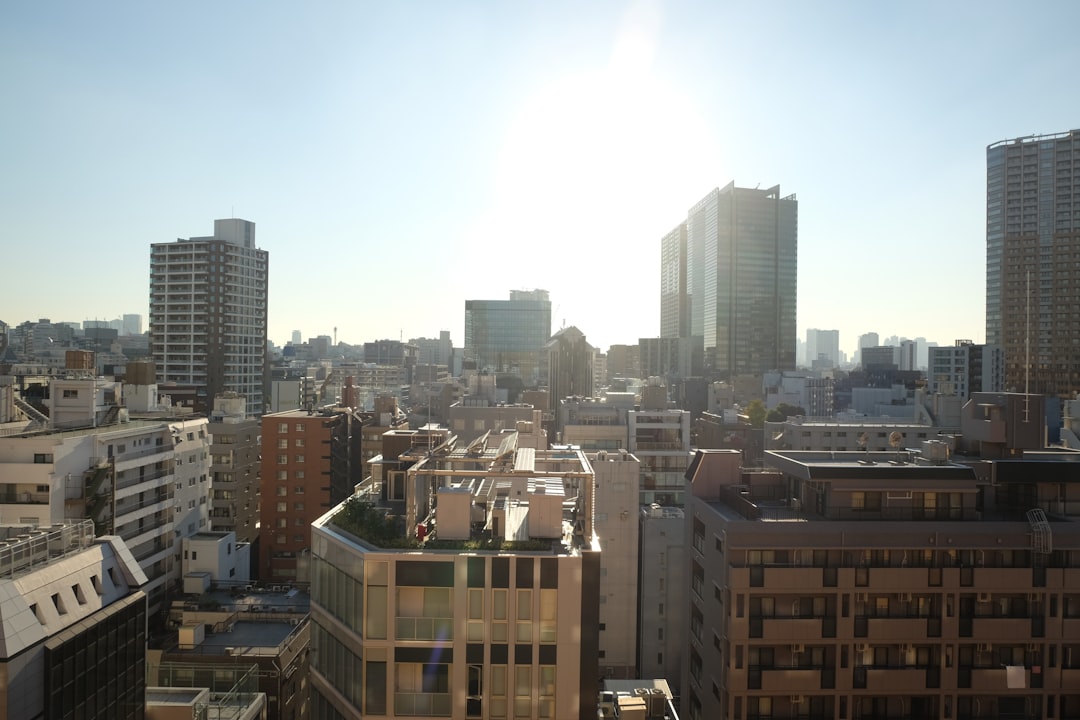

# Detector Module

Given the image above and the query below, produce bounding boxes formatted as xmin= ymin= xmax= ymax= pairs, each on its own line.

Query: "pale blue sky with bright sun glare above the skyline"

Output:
xmin=0 ymin=0 xmax=1080 ymax=352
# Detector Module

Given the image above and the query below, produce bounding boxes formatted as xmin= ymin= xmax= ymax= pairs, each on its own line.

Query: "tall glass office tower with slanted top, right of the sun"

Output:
xmin=678 ymin=182 xmax=798 ymax=378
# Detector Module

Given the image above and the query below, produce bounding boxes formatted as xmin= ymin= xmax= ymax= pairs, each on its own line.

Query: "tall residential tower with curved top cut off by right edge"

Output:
xmin=986 ymin=130 xmax=1080 ymax=396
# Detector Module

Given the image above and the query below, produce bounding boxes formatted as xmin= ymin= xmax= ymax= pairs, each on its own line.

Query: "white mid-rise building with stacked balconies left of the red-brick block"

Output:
xmin=0 ymin=378 xmax=210 ymax=614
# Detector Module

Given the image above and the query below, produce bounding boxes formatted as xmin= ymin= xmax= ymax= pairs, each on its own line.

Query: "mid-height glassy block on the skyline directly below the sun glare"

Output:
xmin=464 ymin=290 xmax=551 ymax=385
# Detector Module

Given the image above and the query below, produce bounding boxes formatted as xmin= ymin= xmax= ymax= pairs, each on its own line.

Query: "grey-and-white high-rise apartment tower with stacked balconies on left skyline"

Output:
xmin=150 ymin=219 xmax=268 ymax=416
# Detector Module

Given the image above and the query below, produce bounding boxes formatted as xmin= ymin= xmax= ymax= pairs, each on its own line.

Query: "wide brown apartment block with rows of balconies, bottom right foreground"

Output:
xmin=683 ymin=440 xmax=1080 ymax=718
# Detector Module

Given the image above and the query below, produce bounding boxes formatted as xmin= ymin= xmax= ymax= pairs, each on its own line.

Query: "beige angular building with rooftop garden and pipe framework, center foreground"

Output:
xmin=311 ymin=433 xmax=600 ymax=720
